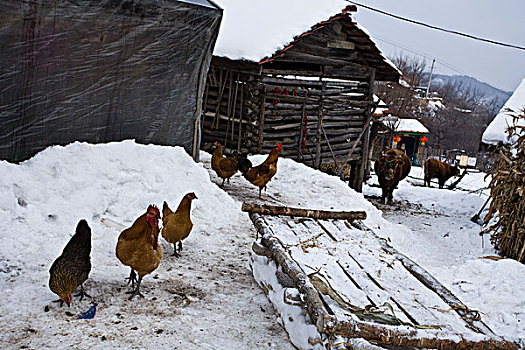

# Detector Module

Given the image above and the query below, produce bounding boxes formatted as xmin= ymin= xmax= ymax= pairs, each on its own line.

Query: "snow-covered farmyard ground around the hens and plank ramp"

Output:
xmin=0 ymin=141 xmax=525 ymax=349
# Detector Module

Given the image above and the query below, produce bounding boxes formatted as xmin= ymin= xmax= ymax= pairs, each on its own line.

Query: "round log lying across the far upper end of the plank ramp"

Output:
xmin=241 ymin=202 xmax=366 ymax=220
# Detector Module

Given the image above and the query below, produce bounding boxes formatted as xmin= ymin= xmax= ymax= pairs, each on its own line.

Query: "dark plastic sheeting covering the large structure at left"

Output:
xmin=0 ymin=0 xmax=222 ymax=162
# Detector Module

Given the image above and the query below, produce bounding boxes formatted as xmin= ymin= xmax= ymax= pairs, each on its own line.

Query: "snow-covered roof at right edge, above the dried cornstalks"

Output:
xmin=481 ymin=78 xmax=525 ymax=145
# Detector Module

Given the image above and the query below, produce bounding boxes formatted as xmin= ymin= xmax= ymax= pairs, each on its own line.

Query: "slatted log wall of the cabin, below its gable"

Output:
xmin=202 ymin=67 xmax=371 ymax=174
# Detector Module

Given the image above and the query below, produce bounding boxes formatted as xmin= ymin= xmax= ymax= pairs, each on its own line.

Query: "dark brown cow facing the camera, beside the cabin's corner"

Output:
xmin=374 ymin=148 xmax=412 ymax=204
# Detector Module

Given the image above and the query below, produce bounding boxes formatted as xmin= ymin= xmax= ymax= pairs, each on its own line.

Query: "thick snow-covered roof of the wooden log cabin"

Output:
xmin=213 ymin=0 xmax=401 ymax=78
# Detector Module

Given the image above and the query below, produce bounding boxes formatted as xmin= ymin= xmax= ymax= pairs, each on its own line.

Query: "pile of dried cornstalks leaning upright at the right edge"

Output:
xmin=484 ymin=109 xmax=525 ymax=263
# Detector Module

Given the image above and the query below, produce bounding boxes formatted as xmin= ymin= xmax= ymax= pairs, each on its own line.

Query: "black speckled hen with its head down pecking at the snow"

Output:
xmin=49 ymin=220 xmax=91 ymax=306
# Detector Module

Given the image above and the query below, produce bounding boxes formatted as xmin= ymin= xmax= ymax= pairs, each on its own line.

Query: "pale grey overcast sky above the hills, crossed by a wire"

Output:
xmin=348 ymin=0 xmax=525 ymax=91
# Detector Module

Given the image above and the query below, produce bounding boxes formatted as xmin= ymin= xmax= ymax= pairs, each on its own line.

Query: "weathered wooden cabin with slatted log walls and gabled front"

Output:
xmin=201 ymin=4 xmax=400 ymax=191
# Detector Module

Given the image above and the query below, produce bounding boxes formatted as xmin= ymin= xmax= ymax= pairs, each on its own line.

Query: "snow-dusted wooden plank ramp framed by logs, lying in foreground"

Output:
xmin=243 ymin=204 xmax=523 ymax=349
